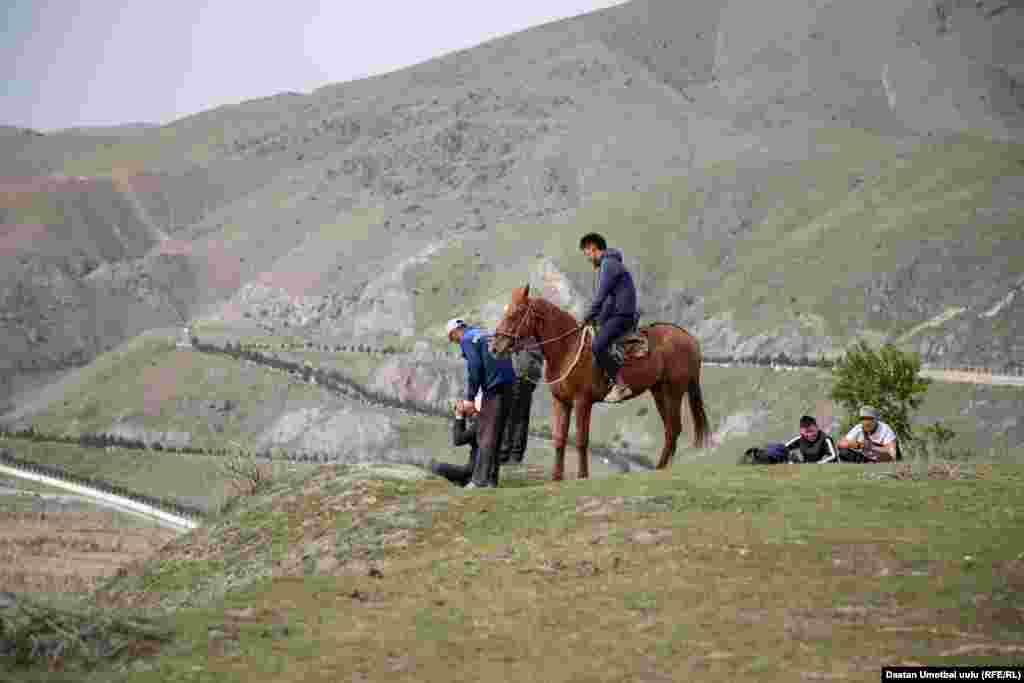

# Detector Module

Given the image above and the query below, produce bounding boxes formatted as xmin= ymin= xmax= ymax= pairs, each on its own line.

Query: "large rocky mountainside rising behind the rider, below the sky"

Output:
xmin=0 ymin=0 xmax=1024 ymax=411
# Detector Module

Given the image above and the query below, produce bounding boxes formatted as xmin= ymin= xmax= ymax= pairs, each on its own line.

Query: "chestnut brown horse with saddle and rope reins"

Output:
xmin=492 ymin=285 xmax=710 ymax=481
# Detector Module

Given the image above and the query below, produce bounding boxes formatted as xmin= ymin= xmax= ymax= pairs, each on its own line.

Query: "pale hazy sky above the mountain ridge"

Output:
xmin=0 ymin=0 xmax=622 ymax=131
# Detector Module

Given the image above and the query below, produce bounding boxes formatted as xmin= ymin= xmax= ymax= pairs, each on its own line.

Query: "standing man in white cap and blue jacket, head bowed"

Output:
xmin=446 ymin=317 xmax=518 ymax=488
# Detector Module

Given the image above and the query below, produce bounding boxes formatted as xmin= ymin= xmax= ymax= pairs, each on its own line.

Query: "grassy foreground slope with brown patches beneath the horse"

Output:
xmin=44 ymin=465 xmax=1024 ymax=682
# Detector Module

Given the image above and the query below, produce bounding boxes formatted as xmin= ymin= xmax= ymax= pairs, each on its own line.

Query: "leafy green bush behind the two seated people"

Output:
xmin=830 ymin=341 xmax=932 ymax=442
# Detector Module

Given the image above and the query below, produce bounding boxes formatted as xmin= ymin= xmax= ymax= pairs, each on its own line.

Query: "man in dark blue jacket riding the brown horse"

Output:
xmin=580 ymin=232 xmax=637 ymax=403
